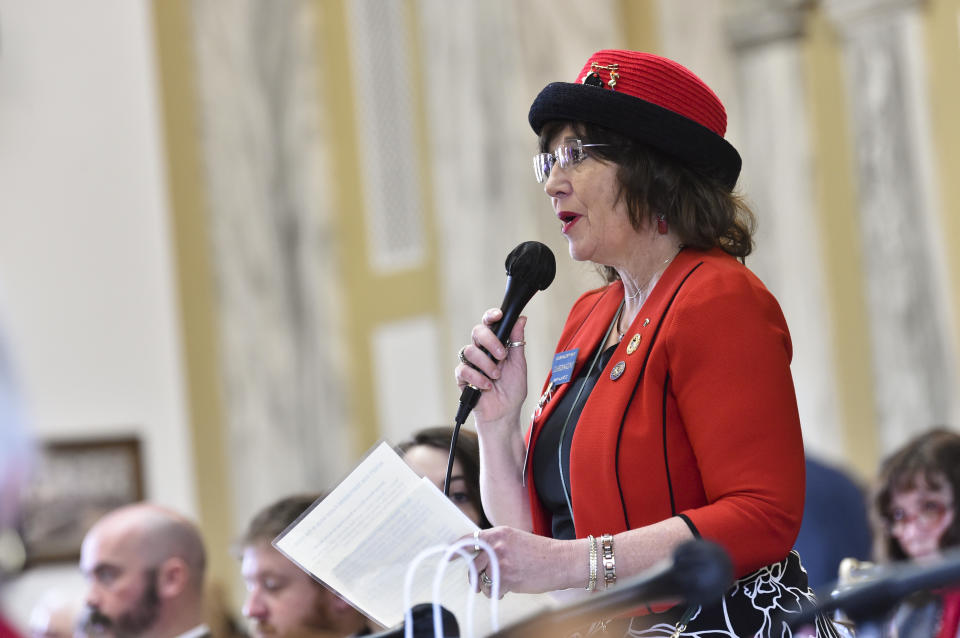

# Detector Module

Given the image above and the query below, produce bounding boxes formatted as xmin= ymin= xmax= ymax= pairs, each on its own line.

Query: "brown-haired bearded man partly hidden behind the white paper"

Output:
xmin=240 ymin=494 xmax=370 ymax=638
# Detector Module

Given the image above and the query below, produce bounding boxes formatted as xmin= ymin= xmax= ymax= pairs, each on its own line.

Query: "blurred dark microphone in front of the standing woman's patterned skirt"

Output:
xmin=490 ymin=540 xmax=733 ymax=638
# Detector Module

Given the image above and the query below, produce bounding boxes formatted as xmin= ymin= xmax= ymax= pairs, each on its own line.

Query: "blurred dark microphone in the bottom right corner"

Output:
xmin=789 ymin=550 xmax=960 ymax=626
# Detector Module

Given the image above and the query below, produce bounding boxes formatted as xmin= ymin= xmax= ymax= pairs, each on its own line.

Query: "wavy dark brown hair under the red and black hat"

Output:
xmin=540 ymin=120 xmax=756 ymax=281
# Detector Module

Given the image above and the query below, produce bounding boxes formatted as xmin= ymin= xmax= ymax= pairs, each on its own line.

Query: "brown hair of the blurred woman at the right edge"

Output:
xmin=873 ymin=428 xmax=960 ymax=560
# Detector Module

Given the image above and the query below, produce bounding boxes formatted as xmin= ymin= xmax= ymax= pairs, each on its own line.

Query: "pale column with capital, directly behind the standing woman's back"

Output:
xmin=726 ymin=0 xmax=844 ymax=461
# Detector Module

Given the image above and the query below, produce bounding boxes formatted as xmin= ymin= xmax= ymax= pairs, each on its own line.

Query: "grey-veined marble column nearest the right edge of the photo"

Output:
xmin=824 ymin=0 xmax=957 ymax=451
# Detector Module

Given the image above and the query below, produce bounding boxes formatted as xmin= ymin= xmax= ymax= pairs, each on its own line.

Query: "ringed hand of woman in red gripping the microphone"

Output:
xmin=455 ymin=308 xmax=527 ymax=423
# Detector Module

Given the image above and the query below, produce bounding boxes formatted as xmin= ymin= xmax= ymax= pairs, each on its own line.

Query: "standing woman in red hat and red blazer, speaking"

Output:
xmin=456 ymin=50 xmax=832 ymax=637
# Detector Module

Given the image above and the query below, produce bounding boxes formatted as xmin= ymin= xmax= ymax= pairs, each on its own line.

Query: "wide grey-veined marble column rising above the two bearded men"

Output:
xmin=190 ymin=0 xmax=351 ymax=529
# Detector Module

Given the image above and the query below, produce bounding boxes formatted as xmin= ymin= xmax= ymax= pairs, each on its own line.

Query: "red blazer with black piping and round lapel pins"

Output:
xmin=524 ymin=249 xmax=804 ymax=577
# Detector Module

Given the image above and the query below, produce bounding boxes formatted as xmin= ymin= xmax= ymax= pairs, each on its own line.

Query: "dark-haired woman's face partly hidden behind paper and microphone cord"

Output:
xmin=397 ymin=426 xmax=491 ymax=529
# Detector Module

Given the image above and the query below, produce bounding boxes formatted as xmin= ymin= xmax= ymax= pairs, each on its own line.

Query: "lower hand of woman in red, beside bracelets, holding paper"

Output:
xmin=468 ymin=526 xmax=576 ymax=596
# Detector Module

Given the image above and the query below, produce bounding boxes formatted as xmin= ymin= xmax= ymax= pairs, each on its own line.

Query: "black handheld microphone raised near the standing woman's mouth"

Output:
xmin=455 ymin=241 xmax=557 ymax=426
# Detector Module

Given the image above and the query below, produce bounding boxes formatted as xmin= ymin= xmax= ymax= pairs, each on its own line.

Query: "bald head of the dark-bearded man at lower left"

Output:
xmin=80 ymin=503 xmax=206 ymax=638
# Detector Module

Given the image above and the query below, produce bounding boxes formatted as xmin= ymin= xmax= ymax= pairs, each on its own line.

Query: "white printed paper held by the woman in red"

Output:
xmin=274 ymin=443 xmax=552 ymax=636
